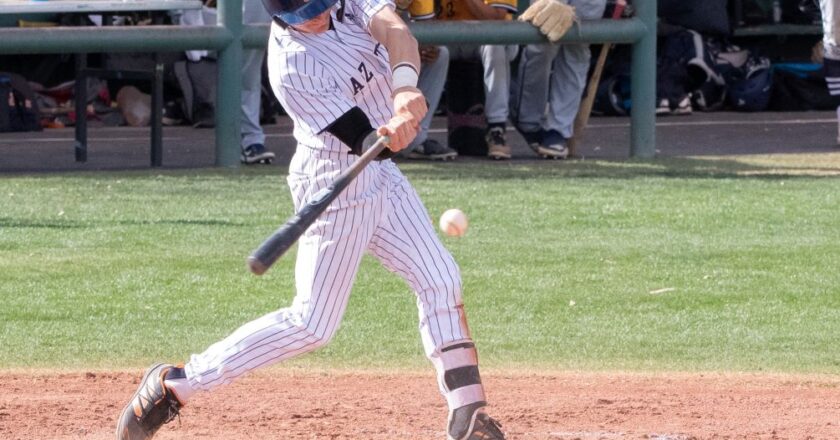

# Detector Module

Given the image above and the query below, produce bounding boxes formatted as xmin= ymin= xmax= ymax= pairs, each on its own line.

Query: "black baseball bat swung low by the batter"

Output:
xmin=248 ymin=136 xmax=389 ymax=275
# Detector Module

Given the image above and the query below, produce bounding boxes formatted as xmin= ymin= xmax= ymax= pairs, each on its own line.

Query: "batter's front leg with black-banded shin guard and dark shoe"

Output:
xmin=369 ymin=163 xmax=504 ymax=440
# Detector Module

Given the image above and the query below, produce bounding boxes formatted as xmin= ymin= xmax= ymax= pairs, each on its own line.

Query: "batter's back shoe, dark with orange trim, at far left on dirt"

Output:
xmin=117 ymin=364 xmax=183 ymax=440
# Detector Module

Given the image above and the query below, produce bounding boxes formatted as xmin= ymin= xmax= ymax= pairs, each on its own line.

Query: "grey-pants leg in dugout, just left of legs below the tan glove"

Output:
xmin=478 ymin=45 xmax=519 ymax=160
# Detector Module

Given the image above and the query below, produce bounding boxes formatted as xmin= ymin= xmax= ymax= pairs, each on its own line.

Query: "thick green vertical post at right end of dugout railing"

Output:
xmin=630 ymin=0 xmax=656 ymax=158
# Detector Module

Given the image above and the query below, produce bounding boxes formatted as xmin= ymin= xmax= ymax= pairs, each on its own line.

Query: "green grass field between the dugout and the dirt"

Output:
xmin=0 ymin=155 xmax=840 ymax=374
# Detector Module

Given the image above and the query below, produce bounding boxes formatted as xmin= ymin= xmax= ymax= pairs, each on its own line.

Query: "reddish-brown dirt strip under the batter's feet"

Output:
xmin=0 ymin=369 xmax=840 ymax=440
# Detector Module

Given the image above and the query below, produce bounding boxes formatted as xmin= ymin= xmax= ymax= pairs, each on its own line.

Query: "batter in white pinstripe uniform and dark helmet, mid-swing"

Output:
xmin=111 ymin=0 xmax=504 ymax=440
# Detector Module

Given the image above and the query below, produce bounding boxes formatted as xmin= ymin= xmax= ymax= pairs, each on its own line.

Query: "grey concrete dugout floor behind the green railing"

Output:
xmin=0 ymin=111 xmax=840 ymax=174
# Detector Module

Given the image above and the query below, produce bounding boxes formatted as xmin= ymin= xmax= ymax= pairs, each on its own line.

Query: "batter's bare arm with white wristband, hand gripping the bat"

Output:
xmin=369 ymin=7 xmax=428 ymax=141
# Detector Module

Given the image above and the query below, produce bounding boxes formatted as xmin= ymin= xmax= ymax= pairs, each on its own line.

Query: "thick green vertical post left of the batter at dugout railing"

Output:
xmin=216 ymin=0 xmax=242 ymax=167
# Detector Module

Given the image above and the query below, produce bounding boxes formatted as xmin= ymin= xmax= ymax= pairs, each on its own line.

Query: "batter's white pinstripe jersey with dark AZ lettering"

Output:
xmin=268 ymin=0 xmax=394 ymax=151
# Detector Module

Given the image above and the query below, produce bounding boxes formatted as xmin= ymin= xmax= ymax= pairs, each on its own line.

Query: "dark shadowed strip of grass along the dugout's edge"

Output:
xmin=1 ymin=151 xmax=840 ymax=181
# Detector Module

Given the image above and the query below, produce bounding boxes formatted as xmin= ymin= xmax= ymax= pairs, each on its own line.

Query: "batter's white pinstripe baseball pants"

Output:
xmin=185 ymin=150 xmax=470 ymax=390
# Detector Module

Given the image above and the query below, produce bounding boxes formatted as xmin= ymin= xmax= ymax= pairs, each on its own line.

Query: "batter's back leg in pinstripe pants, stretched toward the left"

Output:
xmin=180 ymin=153 xmax=385 ymax=390
